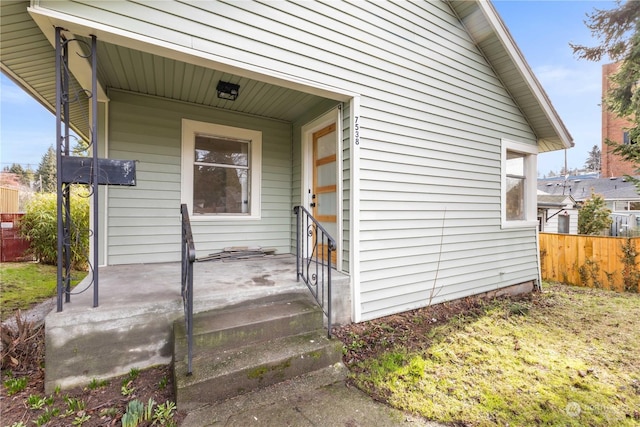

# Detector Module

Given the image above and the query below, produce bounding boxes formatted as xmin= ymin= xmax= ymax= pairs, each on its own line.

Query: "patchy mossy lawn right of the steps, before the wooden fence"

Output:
xmin=347 ymin=284 xmax=640 ymax=426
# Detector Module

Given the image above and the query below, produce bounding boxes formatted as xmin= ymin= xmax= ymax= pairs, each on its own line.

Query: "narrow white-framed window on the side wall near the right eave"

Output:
xmin=501 ymin=140 xmax=538 ymax=228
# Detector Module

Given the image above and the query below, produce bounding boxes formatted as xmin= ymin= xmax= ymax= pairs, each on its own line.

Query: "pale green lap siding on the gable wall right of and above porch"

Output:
xmin=46 ymin=0 xmax=538 ymax=320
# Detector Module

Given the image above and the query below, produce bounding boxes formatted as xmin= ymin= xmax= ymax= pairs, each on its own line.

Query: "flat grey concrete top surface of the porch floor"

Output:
xmin=55 ymin=255 xmax=308 ymax=320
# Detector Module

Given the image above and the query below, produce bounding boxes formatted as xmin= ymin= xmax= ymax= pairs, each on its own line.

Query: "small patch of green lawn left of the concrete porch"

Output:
xmin=0 ymin=262 xmax=87 ymax=321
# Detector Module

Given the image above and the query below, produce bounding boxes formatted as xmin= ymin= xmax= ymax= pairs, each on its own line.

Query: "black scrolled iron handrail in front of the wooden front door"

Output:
xmin=293 ymin=206 xmax=336 ymax=338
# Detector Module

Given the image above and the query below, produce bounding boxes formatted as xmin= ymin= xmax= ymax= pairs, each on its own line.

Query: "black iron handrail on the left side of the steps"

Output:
xmin=180 ymin=203 xmax=196 ymax=375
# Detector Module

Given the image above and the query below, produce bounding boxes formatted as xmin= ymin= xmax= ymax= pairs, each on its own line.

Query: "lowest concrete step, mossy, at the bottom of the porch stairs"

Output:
xmin=174 ymin=329 xmax=342 ymax=410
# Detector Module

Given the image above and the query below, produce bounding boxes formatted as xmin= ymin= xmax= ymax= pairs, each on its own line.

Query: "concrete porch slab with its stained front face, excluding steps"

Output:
xmin=45 ymin=254 xmax=351 ymax=393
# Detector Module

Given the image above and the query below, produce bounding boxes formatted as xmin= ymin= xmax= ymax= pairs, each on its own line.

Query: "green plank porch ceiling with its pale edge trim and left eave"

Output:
xmin=0 ymin=0 xmax=350 ymax=142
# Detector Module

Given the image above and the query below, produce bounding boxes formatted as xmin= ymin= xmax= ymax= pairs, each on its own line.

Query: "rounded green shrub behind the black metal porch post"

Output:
xmin=20 ymin=187 xmax=89 ymax=270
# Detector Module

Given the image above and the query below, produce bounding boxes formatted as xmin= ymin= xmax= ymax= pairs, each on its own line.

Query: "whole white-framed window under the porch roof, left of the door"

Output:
xmin=181 ymin=120 xmax=262 ymax=220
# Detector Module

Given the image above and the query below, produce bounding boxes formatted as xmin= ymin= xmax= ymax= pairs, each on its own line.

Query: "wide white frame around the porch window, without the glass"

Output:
xmin=180 ymin=119 xmax=262 ymax=221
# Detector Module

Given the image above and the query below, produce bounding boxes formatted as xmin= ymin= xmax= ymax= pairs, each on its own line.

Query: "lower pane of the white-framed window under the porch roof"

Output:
xmin=193 ymin=165 xmax=249 ymax=214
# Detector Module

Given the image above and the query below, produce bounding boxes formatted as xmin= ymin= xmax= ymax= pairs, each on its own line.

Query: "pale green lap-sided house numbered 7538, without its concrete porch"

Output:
xmin=0 ymin=0 xmax=572 ymax=322
